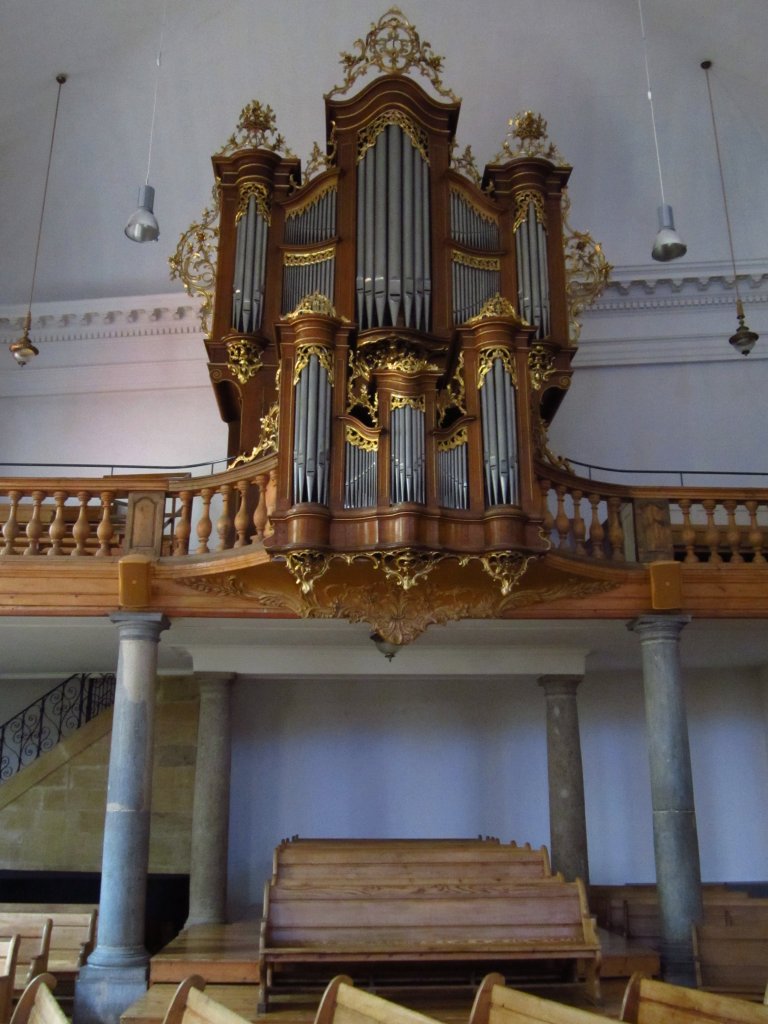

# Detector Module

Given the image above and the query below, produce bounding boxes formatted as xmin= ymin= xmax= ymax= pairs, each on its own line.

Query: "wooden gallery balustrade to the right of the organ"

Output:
xmin=537 ymin=465 xmax=768 ymax=565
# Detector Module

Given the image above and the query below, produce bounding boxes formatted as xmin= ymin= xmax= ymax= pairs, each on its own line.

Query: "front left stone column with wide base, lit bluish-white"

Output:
xmin=73 ymin=611 xmax=170 ymax=1024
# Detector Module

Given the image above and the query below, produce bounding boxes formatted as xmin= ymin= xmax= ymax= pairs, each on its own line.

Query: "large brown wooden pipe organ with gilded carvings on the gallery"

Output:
xmin=192 ymin=8 xmax=602 ymax=569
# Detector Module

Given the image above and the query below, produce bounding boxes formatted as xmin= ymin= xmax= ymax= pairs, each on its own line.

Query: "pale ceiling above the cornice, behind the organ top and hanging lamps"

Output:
xmin=0 ymin=0 xmax=768 ymax=306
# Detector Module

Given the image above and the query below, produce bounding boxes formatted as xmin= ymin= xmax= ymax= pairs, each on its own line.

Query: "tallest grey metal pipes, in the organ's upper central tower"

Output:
xmin=355 ymin=124 xmax=431 ymax=331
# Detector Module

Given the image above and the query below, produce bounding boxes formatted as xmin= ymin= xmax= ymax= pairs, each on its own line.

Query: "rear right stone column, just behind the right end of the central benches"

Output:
xmin=539 ymin=676 xmax=589 ymax=885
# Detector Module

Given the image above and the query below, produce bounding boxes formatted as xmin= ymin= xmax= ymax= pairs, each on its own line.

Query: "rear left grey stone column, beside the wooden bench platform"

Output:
xmin=184 ymin=672 xmax=236 ymax=928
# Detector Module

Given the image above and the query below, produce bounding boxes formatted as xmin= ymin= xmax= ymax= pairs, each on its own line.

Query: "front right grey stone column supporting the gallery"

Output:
xmin=629 ymin=615 xmax=701 ymax=986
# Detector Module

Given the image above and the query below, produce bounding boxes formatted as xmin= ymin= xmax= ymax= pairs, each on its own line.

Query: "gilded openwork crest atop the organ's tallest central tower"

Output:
xmin=326 ymin=7 xmax=459 ymax=102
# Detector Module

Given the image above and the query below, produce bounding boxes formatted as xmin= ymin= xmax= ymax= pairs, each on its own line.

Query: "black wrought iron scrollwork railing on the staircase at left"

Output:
xmin=0 ymin=672 xmax=115 ymax=782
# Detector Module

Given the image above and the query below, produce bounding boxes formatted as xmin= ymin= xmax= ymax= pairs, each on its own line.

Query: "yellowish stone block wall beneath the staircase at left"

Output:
xmin=0 ymin=677 xmax=199 ymax=874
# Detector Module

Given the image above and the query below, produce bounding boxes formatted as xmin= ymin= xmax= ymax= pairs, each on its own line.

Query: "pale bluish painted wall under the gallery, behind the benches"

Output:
xmin=229 ymin=672 xmax=768 ymax=918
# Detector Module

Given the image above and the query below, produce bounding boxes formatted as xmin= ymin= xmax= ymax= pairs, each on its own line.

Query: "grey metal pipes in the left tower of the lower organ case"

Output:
xmin=293 ymin=353 xmax=331 ymax=505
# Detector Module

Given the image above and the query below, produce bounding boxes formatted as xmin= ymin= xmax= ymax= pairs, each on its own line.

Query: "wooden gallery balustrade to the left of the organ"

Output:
xmin=0 ymin=457 xmax=278 ymax=558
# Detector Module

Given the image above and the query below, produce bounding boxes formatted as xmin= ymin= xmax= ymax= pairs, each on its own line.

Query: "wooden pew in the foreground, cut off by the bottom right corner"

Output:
xmin=618 ymin=973 xmax=768 ymax=1024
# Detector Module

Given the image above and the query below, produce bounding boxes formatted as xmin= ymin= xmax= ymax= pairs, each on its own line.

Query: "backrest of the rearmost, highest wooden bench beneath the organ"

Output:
xmin=272 ymin=838 xmax=552 ymax=885
